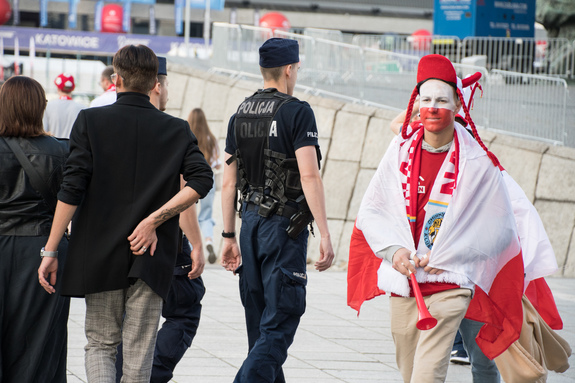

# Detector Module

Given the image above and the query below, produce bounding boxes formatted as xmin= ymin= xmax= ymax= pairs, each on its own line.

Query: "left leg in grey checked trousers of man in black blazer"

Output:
xmin=84 ymin=289 xmax=126 ymax=383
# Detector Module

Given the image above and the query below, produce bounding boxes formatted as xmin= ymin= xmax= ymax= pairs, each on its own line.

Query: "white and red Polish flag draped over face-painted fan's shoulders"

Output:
xmin=348 ymin=124 xmax=524 ymax=359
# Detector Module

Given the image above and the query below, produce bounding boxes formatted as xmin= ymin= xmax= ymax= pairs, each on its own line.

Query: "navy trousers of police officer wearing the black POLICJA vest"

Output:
xmin=234 ymin=205 xmax=309 ymax=383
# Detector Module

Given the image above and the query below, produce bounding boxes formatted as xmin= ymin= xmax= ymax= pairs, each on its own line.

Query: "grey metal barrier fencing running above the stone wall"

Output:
xmin=212 ymin=23 xmax=575 ymax=144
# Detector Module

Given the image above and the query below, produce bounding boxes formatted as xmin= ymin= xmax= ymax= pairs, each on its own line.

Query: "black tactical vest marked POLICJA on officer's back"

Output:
xmin=230 ymin=89 xmax=303 ymax=216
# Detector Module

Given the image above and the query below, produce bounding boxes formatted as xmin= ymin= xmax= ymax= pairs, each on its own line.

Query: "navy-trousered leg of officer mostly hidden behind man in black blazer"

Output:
xmin=150 ymin=275 xmax=205 ymax=383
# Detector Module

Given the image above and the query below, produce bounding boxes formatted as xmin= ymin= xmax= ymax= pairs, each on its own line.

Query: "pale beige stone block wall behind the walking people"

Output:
xmin=167 ymin=63 xmax=575 ymax=277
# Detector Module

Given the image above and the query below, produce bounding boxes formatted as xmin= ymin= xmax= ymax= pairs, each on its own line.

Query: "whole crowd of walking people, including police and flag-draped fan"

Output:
xmin=0 ymin=38 xmax=561 ymax=383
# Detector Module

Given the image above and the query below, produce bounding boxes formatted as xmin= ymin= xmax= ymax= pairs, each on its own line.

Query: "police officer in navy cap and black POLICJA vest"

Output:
xmin=222 ymin=38 xmax=334 ymax=383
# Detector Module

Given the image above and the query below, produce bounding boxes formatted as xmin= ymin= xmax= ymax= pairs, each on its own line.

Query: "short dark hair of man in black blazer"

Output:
xmin=112 ymin=45 xmax=158 ymax=94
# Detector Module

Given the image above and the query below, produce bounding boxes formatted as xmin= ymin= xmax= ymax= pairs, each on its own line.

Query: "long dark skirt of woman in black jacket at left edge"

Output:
xmin=0 ymin=236 xmax=70 ymax=383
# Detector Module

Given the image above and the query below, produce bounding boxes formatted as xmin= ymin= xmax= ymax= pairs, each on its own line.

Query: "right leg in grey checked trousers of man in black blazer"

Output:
xmin=120 ymin=279 xmax=162 ymax=383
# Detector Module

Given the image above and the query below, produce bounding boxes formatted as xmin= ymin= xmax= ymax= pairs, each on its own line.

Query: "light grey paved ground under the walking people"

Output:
xmin=68 ymin=265 xmax=575 ymax=383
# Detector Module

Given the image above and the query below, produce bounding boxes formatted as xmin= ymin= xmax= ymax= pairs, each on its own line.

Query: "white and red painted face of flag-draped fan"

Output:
xmin=419 ymin=80 xmax=457 ymax=132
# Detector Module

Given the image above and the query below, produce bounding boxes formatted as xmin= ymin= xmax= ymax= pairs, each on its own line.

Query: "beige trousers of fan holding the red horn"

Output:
xmin=389 ymin=289 xmax=471 ymax=383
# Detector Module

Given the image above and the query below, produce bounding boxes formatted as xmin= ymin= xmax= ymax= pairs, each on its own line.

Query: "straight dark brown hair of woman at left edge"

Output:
xmin=0 ymin=76 xmax=47 ymax=137
